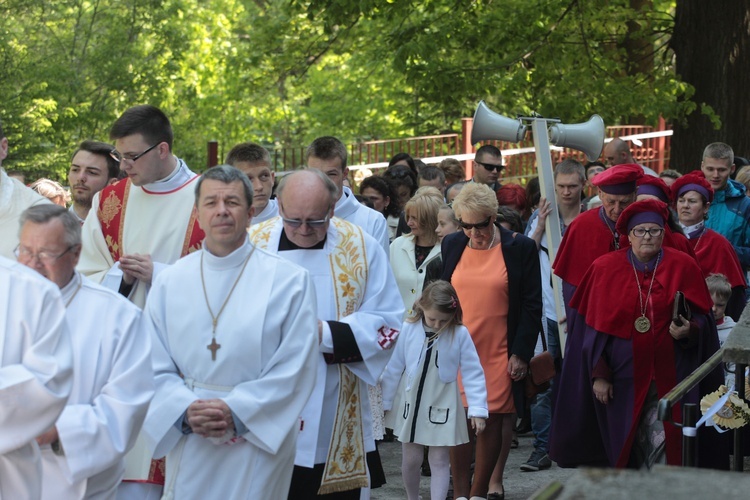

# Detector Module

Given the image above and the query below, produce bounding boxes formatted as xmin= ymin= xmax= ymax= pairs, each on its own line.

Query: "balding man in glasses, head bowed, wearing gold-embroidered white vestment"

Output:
xmin=250 ymin=169 xmax=404 ymax=500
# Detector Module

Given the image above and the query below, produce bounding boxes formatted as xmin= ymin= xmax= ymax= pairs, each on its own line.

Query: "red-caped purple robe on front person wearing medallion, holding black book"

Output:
xmin=550 ymin=248 xmax=721 ymax=467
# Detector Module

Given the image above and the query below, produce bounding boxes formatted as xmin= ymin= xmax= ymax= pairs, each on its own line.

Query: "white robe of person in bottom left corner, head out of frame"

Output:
xmin=0 ymin=257 xmax=73 ymax=500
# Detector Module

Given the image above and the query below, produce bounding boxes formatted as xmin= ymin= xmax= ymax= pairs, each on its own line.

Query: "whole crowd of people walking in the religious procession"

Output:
xmin=0 ymin=105 xmax=750 ymax=500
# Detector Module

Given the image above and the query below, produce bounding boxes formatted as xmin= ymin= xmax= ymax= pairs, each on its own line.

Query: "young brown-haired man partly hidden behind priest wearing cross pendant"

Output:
xmin=226 ymin=142 xmax=279 ymax=224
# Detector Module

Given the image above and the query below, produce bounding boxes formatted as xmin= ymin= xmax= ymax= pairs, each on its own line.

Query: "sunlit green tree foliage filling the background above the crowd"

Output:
xmin=0 ymin=0 xmax=695 ymax=181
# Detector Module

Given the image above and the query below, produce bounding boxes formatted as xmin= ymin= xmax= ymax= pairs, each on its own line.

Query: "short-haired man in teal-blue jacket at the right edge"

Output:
xmin=701 ymin=142 xmax=750 ymax=270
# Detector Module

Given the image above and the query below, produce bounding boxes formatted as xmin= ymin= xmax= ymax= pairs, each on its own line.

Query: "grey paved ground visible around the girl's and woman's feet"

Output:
xmin=372 ymin=437 xmax=575 ymax=500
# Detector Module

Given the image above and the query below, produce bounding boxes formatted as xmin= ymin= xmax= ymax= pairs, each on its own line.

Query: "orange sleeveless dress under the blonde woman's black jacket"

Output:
xmin=451 ymin=245 xmax=516 ymax=413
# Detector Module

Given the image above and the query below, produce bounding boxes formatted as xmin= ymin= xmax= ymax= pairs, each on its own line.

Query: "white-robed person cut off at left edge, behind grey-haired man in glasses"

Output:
xmin=0 ymin=118 xmax=50 ymax=260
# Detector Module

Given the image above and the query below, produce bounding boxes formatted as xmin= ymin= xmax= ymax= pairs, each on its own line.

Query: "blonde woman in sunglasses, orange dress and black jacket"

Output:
xmin=442 ymin=183 xmax=542 ymax=500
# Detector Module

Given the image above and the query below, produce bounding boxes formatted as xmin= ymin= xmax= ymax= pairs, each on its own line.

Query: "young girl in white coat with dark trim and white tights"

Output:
xmin=382 ymin=280 xmax=488 ymax=500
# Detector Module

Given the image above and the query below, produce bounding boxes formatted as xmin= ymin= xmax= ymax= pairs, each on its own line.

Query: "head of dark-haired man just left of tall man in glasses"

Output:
xmin=68 ymin=141 xmax=120 ymax=224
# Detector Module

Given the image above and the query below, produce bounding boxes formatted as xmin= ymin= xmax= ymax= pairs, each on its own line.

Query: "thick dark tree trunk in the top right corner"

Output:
xmin=670 ymin=0 xmax=750 ymax=172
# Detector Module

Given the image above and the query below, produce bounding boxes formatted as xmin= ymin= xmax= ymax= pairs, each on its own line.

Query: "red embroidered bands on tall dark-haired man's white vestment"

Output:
xmin=97 ymin=176 xmax=205 ymax=262
